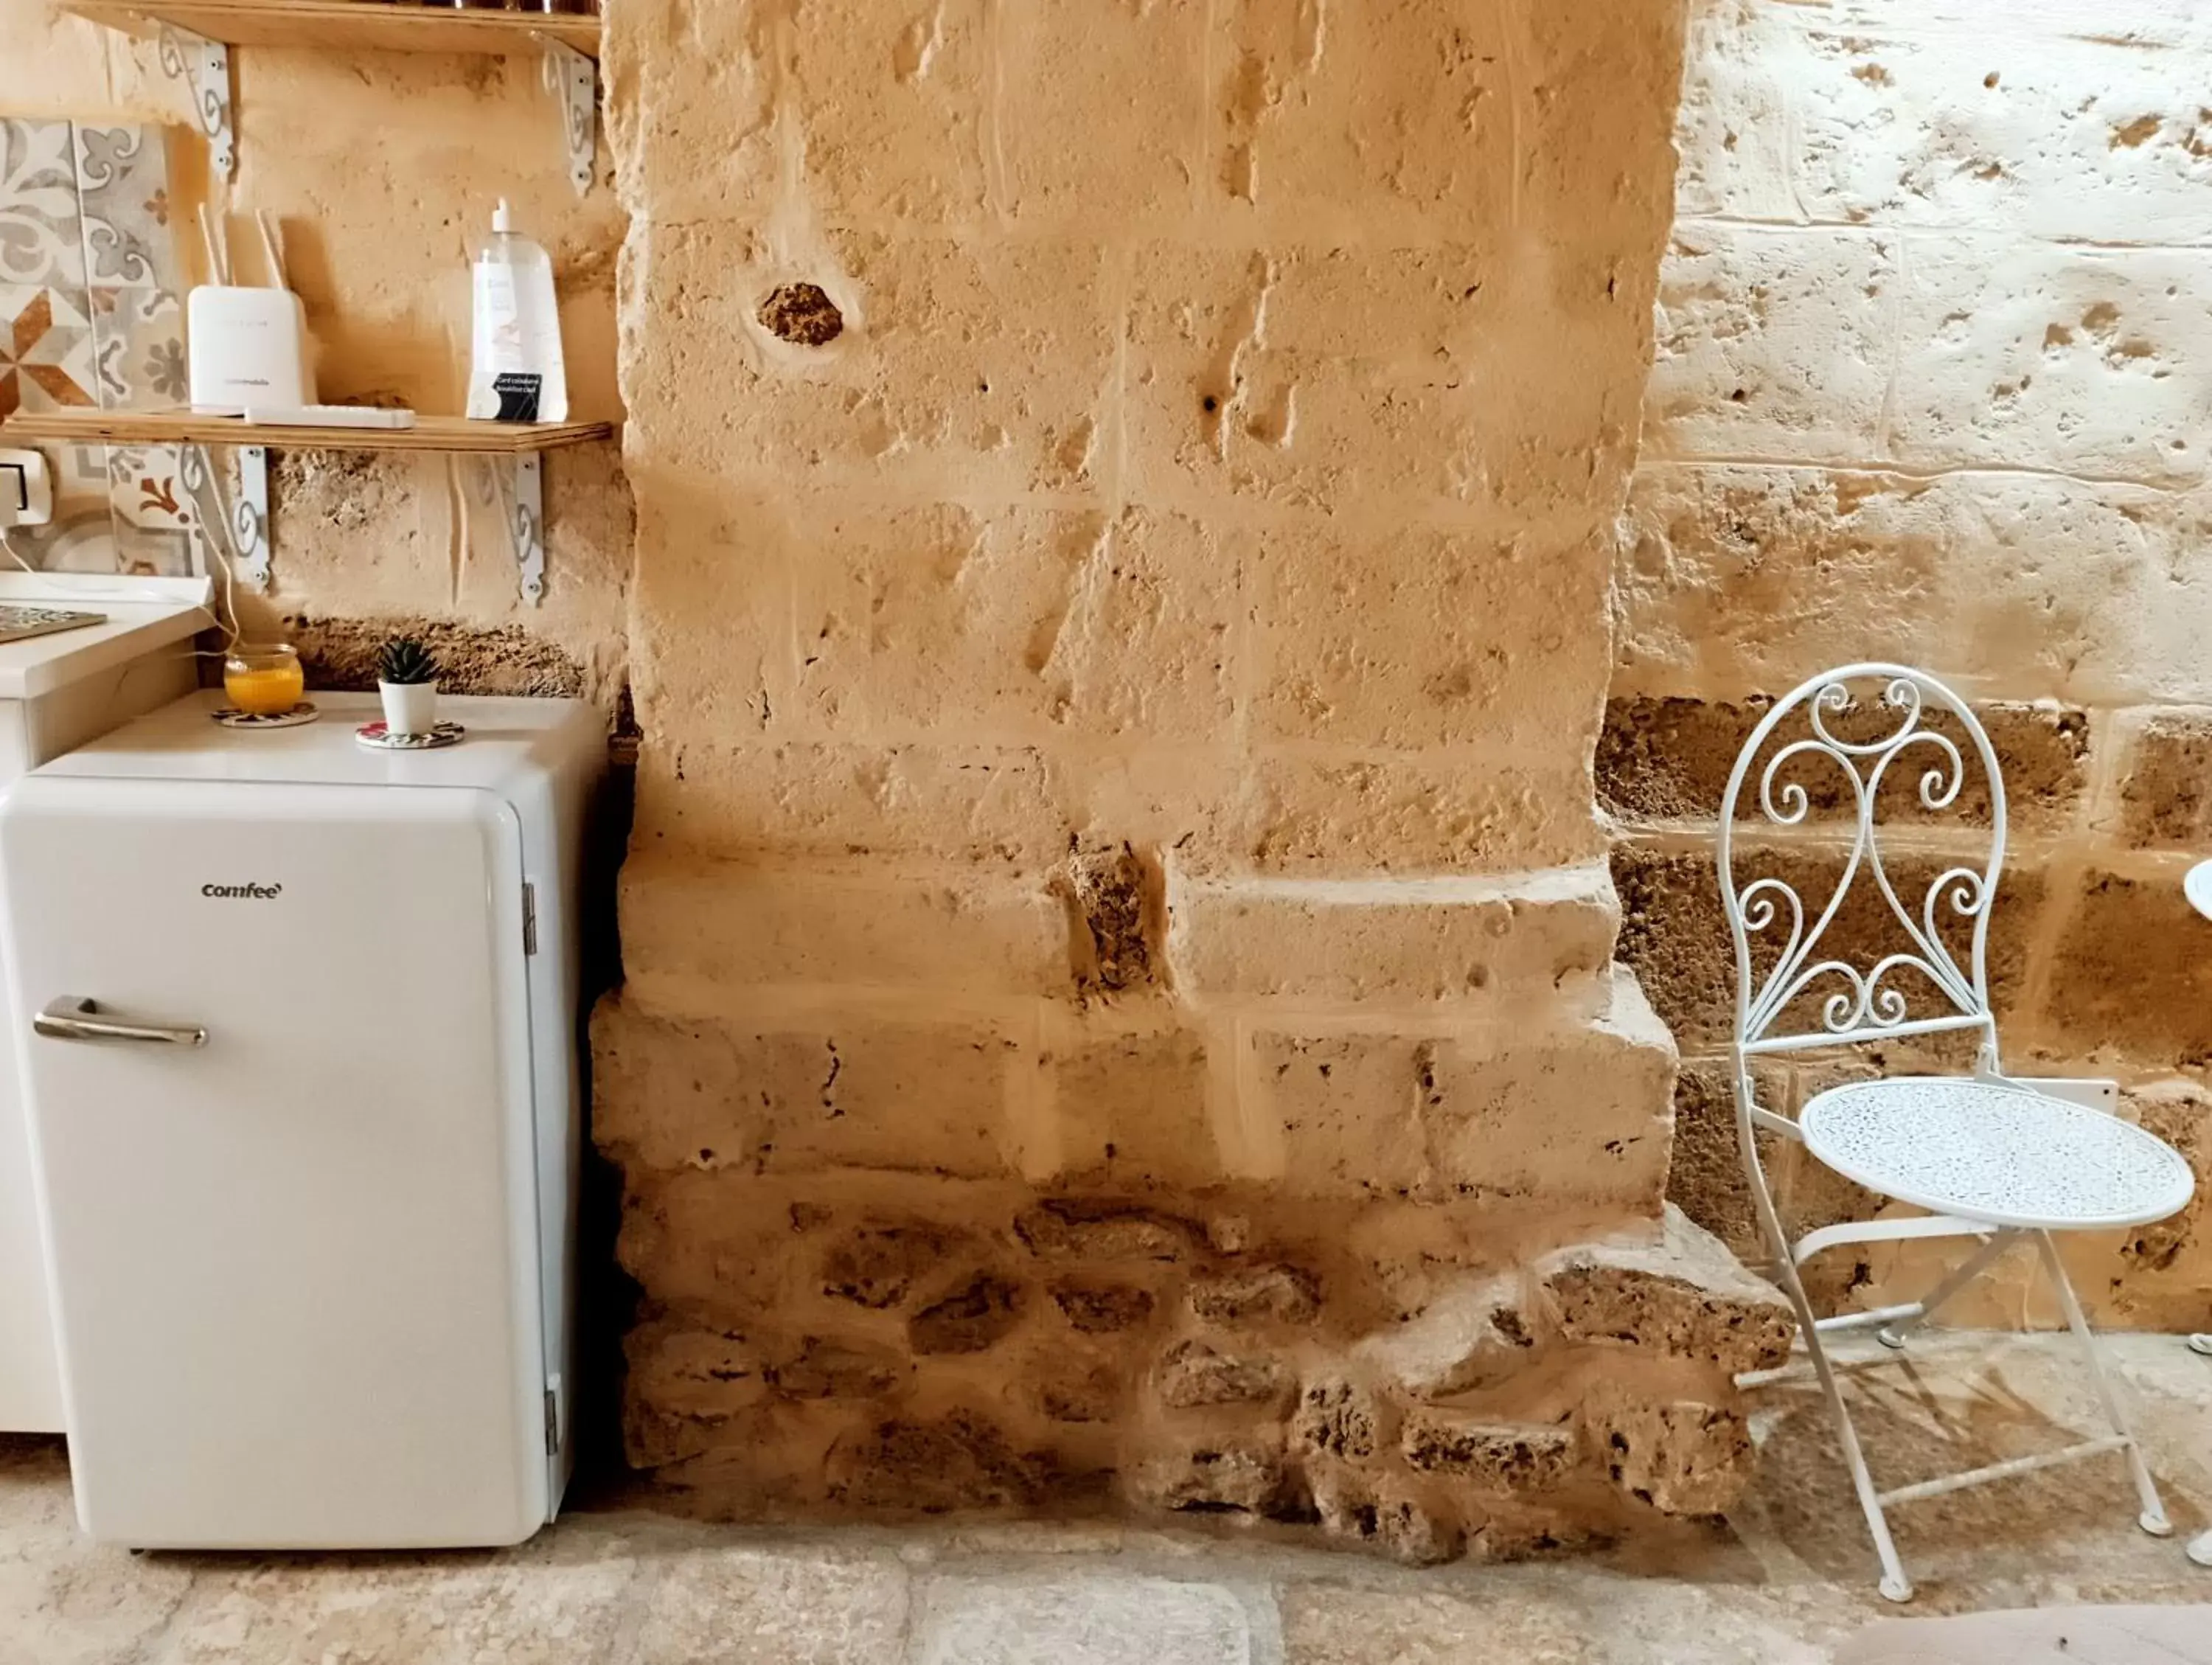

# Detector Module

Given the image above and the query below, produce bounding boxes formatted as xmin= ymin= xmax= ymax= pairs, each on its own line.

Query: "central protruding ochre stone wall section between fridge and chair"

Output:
xmin=595 ymin=0 xmax=1787 ymax=1559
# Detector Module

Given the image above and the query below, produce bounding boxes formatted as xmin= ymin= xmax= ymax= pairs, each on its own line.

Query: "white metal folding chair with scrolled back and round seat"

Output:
xmin=1719 ymin=664 xmax=2194 ymax=1601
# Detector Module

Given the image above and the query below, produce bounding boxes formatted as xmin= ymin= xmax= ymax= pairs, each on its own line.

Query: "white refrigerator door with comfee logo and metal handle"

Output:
xmin=0 ymin=776 xmax=549 ymax=1548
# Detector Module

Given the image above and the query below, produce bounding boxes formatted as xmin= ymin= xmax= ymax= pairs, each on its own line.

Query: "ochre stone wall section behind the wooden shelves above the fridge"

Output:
xmin=0 ymin=0 xmax=630 ymax=706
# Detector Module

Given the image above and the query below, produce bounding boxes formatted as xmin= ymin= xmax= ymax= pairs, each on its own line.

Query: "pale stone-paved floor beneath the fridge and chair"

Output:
xmin=0 ymin=1335 xmax=2212 ymax=1665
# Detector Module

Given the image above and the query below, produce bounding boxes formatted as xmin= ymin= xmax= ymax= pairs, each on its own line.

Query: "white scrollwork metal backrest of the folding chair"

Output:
xmin=1719 ymin=664 xmax=2004 ymax=1057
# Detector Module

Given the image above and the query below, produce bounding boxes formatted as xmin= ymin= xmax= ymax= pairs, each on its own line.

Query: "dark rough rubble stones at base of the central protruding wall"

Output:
xmin=630 ymin=1183 xmax=1792 ymax=1561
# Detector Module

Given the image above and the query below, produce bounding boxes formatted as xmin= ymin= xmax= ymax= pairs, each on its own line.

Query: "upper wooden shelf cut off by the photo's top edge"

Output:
xmin=62 ymin=0 xmax=599 ymax=58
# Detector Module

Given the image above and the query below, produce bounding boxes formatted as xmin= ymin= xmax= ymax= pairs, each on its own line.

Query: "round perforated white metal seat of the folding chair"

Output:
xmin=1798 ymin=1074 xmax=2197 ymax=1231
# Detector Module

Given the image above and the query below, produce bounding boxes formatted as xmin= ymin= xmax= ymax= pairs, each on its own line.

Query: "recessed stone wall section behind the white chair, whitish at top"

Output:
xmin=1597 ymin=0 xmax=2212 ymax=1329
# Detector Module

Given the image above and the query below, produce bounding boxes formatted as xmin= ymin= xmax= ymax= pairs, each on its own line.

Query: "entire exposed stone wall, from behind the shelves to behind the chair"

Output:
xmin=17 ymin=0 xmax=2212 ymax=1561
